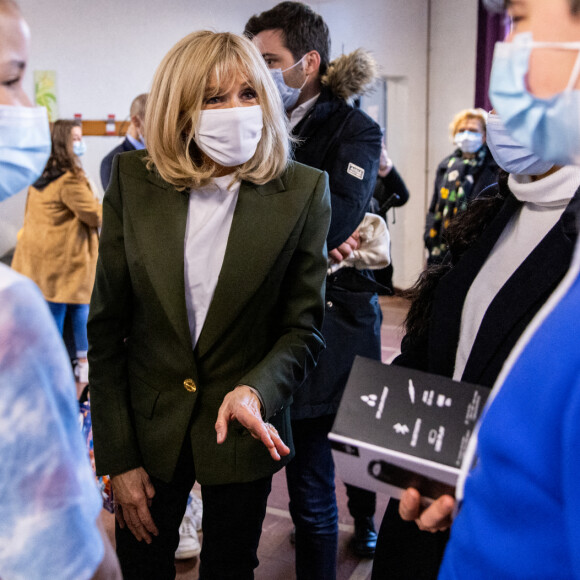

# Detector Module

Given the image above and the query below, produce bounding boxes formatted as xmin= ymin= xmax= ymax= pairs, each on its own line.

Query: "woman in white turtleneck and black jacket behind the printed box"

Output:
xmin=373 ymin=113 xmax=580 ymax=579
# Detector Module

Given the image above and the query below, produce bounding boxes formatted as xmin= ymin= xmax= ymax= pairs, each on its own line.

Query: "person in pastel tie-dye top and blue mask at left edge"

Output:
xmin=0 ymin=0 xmax=121 ymax=580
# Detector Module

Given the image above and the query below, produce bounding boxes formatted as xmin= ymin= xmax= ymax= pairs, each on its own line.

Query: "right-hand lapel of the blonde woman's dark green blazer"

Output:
xmin=196 ymin=179 xmax=306 ymax=357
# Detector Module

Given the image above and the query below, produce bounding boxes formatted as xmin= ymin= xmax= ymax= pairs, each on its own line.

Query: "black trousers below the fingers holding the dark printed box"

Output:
xmin=372 ymin=499 xmax=449 ymax=580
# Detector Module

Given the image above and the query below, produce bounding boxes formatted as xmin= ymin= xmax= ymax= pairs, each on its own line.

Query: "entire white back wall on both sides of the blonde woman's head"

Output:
xmin=0 ymin=0 xmax=477 ymax=287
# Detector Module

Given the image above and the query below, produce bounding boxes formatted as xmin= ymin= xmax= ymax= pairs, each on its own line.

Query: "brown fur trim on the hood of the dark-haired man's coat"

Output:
xmin=321 ymin=48 xmax=377 ymax=101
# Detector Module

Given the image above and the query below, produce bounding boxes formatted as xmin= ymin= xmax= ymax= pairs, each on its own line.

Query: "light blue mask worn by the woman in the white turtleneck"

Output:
xmin=486 ymin=113 xmax=554 ymax=175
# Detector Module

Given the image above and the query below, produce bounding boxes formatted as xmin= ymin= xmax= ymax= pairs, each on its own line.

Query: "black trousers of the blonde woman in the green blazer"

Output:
xmin=115 ymin=437 xmax=272 ymax=580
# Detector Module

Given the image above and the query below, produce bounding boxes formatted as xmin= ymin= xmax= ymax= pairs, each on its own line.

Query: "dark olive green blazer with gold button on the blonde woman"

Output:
xmin=88 ymin=151 xmax=330 ymax=485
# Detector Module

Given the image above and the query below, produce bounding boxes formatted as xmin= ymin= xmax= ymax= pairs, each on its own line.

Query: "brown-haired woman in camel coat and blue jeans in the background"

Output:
xmin=12 ymin=120 xmax=103 ymax=384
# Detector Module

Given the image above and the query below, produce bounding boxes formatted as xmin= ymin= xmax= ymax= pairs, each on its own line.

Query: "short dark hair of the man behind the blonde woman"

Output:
xmin=244 ymin=2 xmax=330 ymax=75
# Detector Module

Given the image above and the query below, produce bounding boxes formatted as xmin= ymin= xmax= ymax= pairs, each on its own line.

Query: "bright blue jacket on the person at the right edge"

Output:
xmin=439 ymin=237 xmax=580 ymax=580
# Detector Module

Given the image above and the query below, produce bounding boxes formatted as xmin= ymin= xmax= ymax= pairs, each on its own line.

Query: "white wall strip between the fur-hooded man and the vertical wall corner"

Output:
xmin=321 ymin=0 xmax=428 ymax=287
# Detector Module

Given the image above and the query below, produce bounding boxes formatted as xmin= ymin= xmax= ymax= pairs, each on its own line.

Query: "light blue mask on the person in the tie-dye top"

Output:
xmin=0 ymin=105 xmax=51 ymax=201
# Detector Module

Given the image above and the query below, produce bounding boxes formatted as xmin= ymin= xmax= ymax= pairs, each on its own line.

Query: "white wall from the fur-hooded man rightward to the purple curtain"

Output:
xmin=319 ymin=0 xmax=477 ymax=288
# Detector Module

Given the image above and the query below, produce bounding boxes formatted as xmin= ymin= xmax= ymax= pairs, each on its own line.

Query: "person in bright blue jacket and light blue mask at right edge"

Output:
xmin=400 ymin=0 xmax=580 ymax=579
